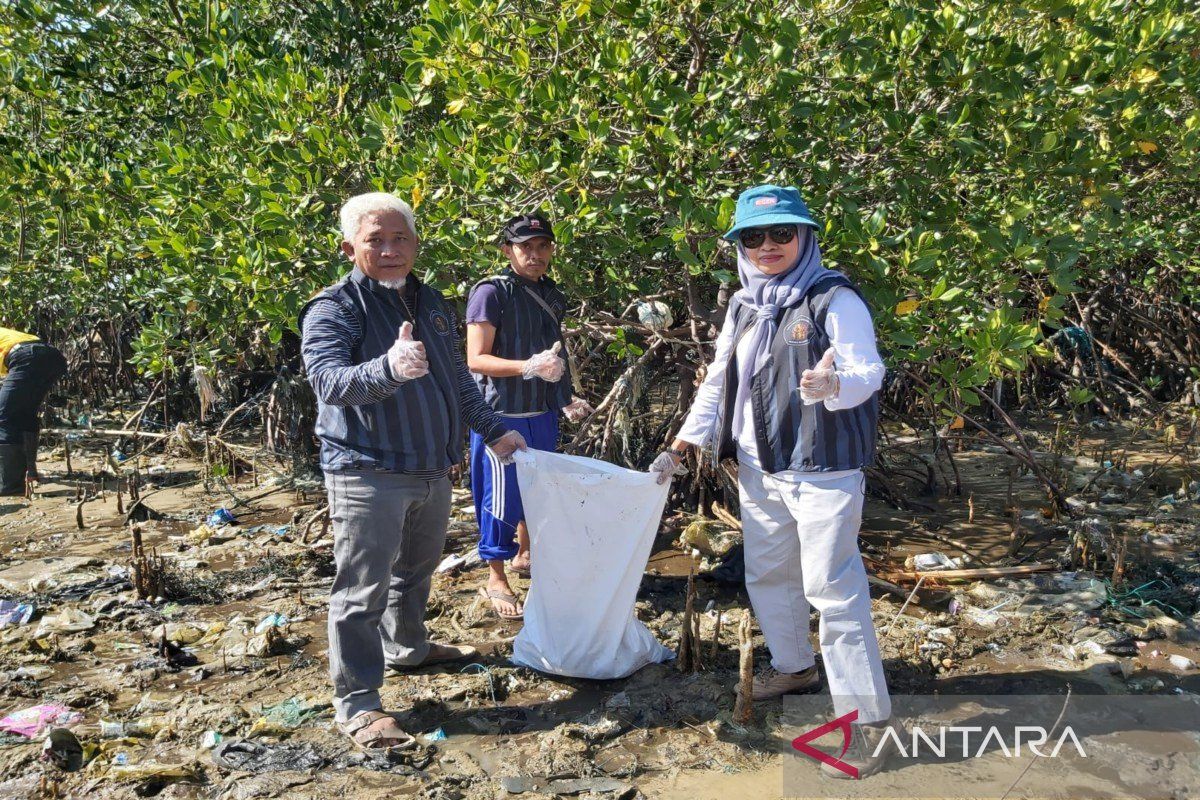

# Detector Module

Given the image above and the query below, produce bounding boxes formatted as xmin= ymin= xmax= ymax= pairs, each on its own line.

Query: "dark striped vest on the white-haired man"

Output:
xmin=300 ymin=267 xmax=464 ymax=473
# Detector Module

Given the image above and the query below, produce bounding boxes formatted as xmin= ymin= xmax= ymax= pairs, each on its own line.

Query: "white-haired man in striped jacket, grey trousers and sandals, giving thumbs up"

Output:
xmin=300 ymin=192 xmax=526 ymax=747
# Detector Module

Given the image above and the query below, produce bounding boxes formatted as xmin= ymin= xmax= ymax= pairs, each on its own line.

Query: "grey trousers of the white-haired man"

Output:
xmin=325 ymin=471 xmax=450 ymax=722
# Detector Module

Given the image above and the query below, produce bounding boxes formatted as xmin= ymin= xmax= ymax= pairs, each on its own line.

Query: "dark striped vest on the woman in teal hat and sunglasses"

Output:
xmin=713 ymin=275 xmax=880 ymax=474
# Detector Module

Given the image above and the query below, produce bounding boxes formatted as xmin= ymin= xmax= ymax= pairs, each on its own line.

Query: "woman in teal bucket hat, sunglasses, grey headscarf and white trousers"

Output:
xmin=650 ymin=186 xmax=894 ymax=777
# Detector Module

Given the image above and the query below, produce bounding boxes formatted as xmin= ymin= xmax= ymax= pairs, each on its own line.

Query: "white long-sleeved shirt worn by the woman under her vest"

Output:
xmin=676 ymin=288 xmax=884 ymax=481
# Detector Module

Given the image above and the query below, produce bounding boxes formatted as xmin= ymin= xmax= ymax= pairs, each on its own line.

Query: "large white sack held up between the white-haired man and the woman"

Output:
xmin=512 ymin=450 xmax=672 ymax=680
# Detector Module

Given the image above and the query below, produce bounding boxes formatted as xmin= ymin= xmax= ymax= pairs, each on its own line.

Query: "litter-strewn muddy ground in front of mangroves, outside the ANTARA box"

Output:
xmin=0 ymin=414 xmax=1200 ymax=800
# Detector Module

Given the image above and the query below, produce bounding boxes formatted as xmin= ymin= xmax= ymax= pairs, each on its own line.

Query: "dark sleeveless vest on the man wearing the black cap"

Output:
xmin=472 ymin=269 xmax=571 ymax=414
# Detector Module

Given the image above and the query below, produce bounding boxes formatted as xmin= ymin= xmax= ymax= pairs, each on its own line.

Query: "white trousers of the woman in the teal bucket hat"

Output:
xmin=738 ymin=464 xmax=892 ymax=723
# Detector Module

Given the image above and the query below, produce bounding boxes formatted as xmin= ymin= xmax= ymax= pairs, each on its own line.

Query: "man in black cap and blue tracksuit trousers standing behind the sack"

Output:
xmin=467 ymin=212 xmax=592 ymax=619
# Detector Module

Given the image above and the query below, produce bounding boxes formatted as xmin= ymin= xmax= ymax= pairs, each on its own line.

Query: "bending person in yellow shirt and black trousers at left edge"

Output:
xmin=0 ymin=327 xmax=67 ymax=495
